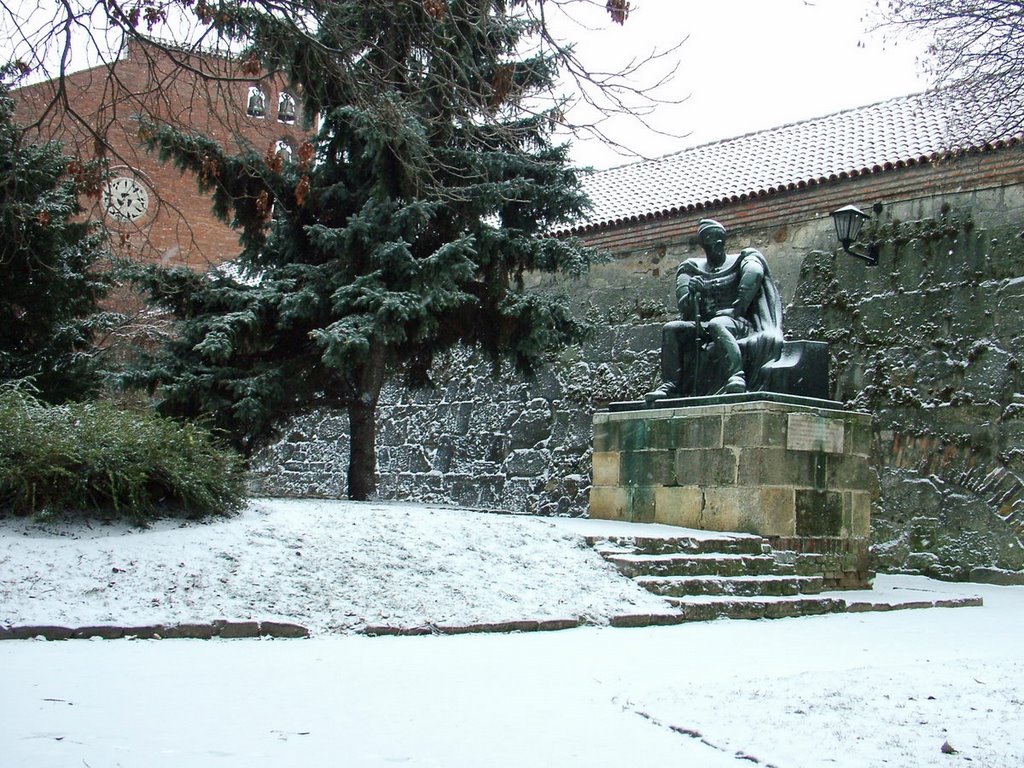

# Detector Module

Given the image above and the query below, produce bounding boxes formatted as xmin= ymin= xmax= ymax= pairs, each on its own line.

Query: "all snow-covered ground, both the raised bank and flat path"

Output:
xmin=0 ymin=502 xmax=1024 ymax=768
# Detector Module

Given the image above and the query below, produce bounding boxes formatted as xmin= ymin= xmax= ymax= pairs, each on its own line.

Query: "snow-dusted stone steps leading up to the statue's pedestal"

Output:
xmin=588 ymin=534 xmax=847 ymax=622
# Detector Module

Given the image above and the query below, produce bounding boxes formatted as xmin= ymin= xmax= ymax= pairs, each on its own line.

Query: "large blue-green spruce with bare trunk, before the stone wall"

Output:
xmin=135 ymin=0 xmax=592 ymax=499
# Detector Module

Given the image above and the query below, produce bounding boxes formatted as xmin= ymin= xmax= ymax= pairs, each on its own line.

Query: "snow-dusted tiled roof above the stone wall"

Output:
xmin=574 ymin=92 xmax=1021 ymax=231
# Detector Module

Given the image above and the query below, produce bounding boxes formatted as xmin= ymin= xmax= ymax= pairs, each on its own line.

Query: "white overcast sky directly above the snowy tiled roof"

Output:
xmin=566 ymin=0 xmax=929 ymax=168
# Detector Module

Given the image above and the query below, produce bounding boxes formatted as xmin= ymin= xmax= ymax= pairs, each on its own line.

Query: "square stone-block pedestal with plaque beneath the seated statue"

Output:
xmin=590 ymin=395 xmax=878 ymax=586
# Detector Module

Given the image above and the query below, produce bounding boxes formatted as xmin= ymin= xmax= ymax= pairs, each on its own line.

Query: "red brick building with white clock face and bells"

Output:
xmin=12 ymin=41 xmax=303 ymax=269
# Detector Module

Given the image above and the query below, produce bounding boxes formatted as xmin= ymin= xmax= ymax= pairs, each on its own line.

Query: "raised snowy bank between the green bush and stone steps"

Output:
xmin=0 ymin=500 xmax=665 ymax=634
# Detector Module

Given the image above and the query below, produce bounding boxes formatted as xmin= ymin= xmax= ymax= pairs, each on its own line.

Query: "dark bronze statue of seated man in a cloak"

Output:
xmin=646 ymin=219 xmax=782 ymax=402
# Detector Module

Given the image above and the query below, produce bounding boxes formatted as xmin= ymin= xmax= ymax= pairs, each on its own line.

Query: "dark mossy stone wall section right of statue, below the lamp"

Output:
xmin=790 ymin=187 xmax=1024 ymax=579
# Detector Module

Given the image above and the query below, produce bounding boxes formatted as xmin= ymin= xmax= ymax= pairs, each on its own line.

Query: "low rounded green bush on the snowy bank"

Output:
xmin=0 ymin=386 xmax=245 ymax=522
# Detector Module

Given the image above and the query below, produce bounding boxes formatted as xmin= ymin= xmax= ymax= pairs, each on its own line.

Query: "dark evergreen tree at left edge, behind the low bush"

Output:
xmin=0 ymin=70 xmax=113 ymax=402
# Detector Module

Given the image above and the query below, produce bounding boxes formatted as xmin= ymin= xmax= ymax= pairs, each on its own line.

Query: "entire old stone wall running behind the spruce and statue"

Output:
xmin=251 ymin=179 xmax=1024 ymax=578
